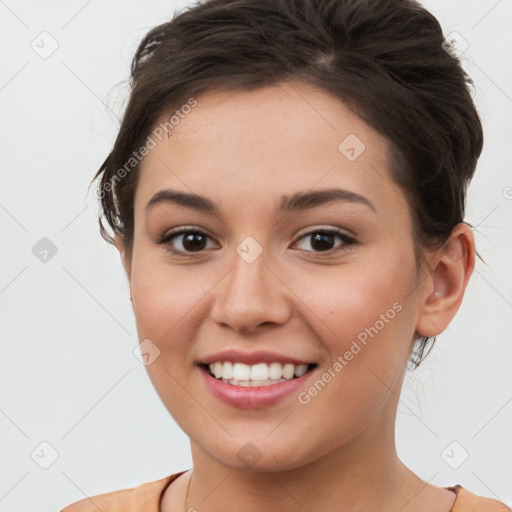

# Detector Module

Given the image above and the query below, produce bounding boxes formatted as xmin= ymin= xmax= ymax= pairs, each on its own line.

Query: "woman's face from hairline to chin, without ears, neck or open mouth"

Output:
xmin=118 ymin=81 xmax=430 ymax=471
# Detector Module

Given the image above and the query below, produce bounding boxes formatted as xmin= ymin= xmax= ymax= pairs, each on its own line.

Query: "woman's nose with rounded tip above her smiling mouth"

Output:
xmin=211 ymin=242 xmax=293 ymax=333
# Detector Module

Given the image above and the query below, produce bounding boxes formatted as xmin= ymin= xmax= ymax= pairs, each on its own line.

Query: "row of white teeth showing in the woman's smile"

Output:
xmin=205 ymin=361 xmax=308 ymax=386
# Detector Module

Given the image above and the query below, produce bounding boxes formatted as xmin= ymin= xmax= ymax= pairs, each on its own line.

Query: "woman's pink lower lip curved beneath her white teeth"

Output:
xmin=199 ymin=367 xmax=316 ymax=408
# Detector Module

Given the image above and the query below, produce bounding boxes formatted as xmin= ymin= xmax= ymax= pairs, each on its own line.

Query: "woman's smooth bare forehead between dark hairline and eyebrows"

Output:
xmin=136 ymin=81 xmax=404 ymax=218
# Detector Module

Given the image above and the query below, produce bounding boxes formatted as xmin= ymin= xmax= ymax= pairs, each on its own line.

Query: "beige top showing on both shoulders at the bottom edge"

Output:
xmin=60 ymin=470 xmax=512 ymax=512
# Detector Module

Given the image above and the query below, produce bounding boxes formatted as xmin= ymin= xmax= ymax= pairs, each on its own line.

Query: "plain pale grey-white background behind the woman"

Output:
xmin=0 ymin=0 xmax=512 ymax=512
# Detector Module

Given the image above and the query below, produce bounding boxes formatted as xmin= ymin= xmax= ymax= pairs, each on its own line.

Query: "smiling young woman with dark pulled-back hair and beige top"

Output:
xmin=64 ymin=0 xmax=510 ymax=512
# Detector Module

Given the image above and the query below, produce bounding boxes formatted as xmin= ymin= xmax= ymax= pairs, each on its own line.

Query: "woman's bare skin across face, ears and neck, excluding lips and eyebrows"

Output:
xmin=115 ymin=81 xmax=475 ymax=512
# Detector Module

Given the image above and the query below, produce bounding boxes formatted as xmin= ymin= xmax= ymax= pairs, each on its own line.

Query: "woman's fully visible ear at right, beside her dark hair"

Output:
xmin=416 ymin=223 xmax=475 ymax=337
